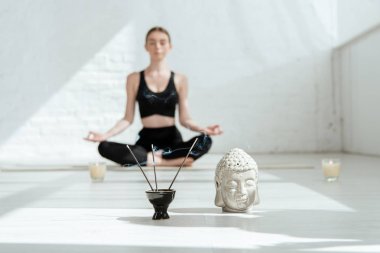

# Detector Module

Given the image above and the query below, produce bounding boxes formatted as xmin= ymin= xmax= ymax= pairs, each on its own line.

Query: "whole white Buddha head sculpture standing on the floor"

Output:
xmin=215 ymin=148 xmax=260 ymax=212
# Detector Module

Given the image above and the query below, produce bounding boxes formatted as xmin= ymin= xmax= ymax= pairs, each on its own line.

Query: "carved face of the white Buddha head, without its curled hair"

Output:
xmin=219 ymin=170 xmax=257 ymax=212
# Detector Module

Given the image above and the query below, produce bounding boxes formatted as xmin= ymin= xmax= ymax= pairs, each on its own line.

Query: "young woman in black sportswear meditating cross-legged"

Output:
xmin=85 ymin=27 xmax=222 ymax=166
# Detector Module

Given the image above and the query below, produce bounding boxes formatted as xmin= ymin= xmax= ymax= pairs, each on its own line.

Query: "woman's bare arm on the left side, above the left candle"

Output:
xmin=85 ymin=73 xmax=139 ymax=142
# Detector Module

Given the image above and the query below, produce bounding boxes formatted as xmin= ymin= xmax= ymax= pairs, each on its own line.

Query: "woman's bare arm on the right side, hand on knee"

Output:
xmin=176 ymin=74 xmax=223 ymax=135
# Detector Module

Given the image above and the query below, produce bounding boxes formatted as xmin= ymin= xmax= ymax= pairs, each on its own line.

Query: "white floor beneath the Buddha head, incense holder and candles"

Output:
xmin=0 ymin=154 xmax=380 ymax=253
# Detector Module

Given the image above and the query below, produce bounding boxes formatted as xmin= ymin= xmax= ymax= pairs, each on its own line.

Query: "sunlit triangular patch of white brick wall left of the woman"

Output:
xmin=0 ymin=22 xmax=142 ymax=163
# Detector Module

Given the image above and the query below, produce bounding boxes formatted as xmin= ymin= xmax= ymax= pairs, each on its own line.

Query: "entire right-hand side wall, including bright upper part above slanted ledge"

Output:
xmin=334 ymin=0 xmax=380 ymax=155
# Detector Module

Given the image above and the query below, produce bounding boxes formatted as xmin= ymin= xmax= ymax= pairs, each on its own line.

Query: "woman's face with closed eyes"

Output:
xmin=145 ymin=31 xmax=172 ymax=60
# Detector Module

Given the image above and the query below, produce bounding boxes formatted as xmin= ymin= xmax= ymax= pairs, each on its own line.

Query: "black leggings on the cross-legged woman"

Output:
xmin=98 ymin=126 xmax=212 ymax=166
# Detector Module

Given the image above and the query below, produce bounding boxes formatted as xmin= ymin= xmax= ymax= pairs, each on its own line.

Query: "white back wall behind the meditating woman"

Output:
xmin=0 ymin=0 xmax=376 ymax=163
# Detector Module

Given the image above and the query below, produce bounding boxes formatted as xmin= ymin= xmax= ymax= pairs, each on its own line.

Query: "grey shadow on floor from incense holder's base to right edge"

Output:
xmin=118 ymin=208 xmax=379 ymax=252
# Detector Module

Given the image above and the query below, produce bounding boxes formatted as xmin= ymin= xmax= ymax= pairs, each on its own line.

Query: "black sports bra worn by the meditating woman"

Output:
xmin=137 ymin=71 xmax=178 ymax=118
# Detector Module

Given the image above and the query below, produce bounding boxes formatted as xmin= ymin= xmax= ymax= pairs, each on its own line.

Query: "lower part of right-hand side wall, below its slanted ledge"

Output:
xmin=336 ymin=26 xmax=380 ymax=155
